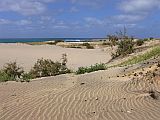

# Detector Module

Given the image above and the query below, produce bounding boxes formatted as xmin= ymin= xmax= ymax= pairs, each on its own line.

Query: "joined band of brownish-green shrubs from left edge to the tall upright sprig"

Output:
xmin=0 ymin=54 xmax=71 ymax=82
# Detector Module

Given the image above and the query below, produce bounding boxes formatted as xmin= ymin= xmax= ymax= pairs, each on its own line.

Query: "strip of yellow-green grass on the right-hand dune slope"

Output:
xmin=119 ymin=46 xmax=160 ymax=66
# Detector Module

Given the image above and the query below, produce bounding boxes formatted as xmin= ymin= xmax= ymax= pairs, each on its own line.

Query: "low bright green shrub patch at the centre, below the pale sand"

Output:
xmin=76 ymin=63 xmax=106 ymax=74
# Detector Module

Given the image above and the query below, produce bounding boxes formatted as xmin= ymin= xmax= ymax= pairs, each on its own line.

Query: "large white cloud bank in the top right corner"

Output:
xmin=114 ymin=0 xmax=160 ymax=22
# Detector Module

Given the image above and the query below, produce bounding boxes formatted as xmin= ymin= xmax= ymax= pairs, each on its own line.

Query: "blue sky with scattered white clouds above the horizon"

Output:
xmin=0 ymin=0 xmax=160 ymax=38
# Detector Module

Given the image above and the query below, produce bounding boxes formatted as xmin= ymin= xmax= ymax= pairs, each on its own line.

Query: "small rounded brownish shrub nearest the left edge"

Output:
xmin=2 ymin=62 xmax=24 ymax=80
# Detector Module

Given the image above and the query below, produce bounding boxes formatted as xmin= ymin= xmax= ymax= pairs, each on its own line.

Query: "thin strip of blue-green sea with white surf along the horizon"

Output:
xmin=0 ymin=38 xmax=103 ymax=43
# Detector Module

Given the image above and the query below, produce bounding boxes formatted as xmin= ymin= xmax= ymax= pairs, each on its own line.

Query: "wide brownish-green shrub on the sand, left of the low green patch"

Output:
xmin=30 ymin=58 xmax=70 ymax=78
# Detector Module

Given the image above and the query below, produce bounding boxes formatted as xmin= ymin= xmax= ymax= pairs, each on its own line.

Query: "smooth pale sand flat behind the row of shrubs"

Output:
xmin=0 ymin=43 xmax=111 ymax=70
